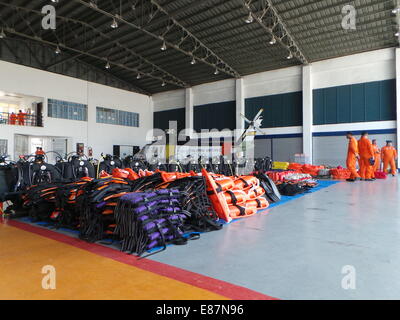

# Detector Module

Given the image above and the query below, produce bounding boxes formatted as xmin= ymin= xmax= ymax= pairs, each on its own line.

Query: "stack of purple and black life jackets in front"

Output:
xmin=115 ymin=189 xmax=192 ymax=256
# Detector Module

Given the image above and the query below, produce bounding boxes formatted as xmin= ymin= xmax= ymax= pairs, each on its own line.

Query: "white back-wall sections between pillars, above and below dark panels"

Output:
xmin=153 ymin=48 xmax=397 ymax=165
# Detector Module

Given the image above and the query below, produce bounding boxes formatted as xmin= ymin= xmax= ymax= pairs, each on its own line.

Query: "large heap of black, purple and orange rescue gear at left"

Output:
xmin=1 ymin=156 xmax=288 ymax=256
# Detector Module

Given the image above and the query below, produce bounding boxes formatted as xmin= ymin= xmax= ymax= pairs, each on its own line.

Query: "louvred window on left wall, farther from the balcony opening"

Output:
xmin=96 ymin=107 xmax=139 ymax=128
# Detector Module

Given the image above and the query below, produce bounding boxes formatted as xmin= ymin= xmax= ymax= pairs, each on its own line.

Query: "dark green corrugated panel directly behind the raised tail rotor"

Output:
xmin=245 ymin=92 xmax=303 ymax=128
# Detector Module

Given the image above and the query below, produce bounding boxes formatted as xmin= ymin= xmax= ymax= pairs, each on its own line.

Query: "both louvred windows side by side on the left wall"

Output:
xmin=48 ymin=99 xmax=139 ymax=127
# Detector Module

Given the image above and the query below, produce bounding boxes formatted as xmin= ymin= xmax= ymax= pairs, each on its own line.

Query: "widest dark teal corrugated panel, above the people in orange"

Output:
xmin=314 ymin=80 xmax=396 ymax=125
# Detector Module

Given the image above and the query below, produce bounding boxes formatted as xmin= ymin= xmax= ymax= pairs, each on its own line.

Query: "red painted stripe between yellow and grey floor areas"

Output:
xmin=0 ymin=219 xmax=278 ymax=300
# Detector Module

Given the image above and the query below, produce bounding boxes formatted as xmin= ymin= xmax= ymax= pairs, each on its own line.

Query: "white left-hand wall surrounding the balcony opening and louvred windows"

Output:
xmin=0 ymin=61 xmax=153 ymax=157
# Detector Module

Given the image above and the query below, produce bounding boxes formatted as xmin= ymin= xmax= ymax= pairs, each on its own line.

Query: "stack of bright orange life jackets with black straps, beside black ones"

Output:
xmin=202 ymin=169 xmax=269 ymax=222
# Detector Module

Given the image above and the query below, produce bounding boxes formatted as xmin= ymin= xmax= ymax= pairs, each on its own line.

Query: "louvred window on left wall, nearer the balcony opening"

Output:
xmin=47 ymin=99 xmax=87 ymax=121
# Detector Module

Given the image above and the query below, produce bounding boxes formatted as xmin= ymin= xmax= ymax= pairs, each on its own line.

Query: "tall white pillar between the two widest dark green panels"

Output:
xmin=303 ymin=65 xmax=313 ymax=164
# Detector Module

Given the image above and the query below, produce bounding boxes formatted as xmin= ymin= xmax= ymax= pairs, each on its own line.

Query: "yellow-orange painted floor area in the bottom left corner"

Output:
xmin=0 ymin=224 xmax=226 ymax=300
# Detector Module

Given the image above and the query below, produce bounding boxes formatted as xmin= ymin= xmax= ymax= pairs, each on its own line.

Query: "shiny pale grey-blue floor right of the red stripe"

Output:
xmin=153 ymin=177 xmax=400 ymax=299
